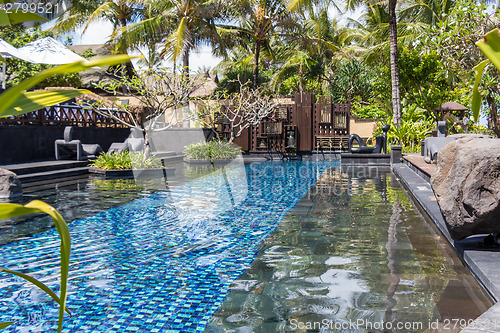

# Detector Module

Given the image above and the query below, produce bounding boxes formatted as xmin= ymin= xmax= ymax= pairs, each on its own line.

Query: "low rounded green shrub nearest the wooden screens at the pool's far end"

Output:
xmin=184 ymin=140 xmax=241 ymax=160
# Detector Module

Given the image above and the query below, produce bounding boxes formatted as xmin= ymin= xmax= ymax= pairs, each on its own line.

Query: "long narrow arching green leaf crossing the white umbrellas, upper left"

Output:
xmin=0 ymin=55 xmax=135 ymax=117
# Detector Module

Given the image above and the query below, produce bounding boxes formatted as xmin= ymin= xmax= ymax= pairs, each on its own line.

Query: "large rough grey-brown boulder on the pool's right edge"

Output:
xmin=431 ymin=136 xmax=500 ymax=240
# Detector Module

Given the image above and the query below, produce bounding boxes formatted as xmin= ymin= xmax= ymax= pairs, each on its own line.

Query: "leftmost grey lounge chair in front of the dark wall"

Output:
xmin=55 ymin=126 xmax=102 ymax=161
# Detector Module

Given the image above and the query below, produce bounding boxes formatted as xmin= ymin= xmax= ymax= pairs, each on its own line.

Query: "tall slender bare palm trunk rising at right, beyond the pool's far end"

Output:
xmin=389 ymin=0 xmax=401 ymax=128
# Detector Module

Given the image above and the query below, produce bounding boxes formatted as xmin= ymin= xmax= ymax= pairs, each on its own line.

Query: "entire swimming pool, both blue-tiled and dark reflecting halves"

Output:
xmin=0 ymin=162 xmax=491 ymax=332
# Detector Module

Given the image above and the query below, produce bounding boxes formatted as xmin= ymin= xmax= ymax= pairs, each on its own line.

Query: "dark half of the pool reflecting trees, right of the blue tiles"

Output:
xmin=206 ymin=167 xmax=492 ymax=332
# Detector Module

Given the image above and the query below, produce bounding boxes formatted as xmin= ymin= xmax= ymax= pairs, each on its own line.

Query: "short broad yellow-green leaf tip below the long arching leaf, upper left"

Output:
xmin=0 ymin=89 xmax=90 ymax=118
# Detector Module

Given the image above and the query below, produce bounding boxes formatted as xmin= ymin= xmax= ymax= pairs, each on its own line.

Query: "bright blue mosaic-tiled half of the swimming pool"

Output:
xmin=0 ymin=162 xmax=334 ymax=333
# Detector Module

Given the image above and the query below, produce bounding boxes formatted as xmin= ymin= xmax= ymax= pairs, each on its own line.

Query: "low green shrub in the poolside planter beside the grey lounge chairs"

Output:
xmin=91 ymin=150 xmax=163 ymax=170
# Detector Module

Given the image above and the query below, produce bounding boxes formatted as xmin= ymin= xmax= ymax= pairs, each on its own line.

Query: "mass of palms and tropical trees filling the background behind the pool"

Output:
xmin=0 ymin=0 xmax=500 ymax=145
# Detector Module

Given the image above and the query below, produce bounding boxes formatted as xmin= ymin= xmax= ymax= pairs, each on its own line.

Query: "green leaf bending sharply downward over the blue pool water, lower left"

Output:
xmin=0 ymin=200 xmax=71 ymax=332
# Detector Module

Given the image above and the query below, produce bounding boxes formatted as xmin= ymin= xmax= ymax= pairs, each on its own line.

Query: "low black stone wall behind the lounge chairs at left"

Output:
xmin=0 ymin=125 xmax=130 ymax=165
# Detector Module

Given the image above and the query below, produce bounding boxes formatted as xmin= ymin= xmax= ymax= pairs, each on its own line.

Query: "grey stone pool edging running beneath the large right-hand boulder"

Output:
xmin=392 ymin=163 xmax=500 ymax=333
